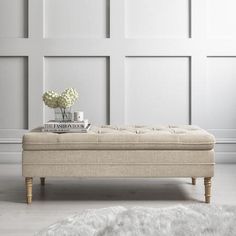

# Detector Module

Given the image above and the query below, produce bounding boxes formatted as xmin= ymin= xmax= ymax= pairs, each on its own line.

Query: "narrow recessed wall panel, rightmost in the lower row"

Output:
xmin=206 ymin=57 xmax=236 ymax=129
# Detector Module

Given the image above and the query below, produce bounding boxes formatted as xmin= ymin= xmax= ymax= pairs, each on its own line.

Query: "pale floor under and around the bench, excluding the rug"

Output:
xmin=0 ymin=164 xmax=236 ymax=236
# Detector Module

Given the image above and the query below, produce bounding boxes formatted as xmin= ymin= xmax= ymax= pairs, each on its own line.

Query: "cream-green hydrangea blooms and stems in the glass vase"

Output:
xmin=43 ymin=88 xmax=79 ymax=121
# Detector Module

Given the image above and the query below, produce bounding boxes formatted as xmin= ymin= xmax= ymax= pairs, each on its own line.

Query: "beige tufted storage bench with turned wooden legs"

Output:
xmin=22 ymin=126 xmax=215 ymax=203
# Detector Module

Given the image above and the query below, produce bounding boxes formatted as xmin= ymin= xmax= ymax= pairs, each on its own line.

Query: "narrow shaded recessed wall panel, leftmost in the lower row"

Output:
xmin=0 ymin=57 xmax=28 ymax=129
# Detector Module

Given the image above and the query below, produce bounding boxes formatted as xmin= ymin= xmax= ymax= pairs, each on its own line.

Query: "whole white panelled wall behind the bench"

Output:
xmin=0 ymin=0 xmax=236 ymax=163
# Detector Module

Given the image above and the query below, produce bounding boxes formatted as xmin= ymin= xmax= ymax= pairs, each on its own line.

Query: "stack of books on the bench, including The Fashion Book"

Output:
xmin=43 ymin=120 xmax=91 ymax=133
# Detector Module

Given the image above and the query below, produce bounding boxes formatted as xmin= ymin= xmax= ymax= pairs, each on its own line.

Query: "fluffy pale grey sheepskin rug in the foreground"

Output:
xmin=35 ymin=204 xmax=236 ymax=236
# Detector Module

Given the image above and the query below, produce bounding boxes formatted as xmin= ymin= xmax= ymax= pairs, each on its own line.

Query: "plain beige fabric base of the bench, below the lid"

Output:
xmin=23 ymin=150 xmax=214 ymax=178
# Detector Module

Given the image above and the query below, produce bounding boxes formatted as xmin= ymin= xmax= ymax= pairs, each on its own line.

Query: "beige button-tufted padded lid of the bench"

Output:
xmin=23 ymin=125 xmax=215 ymax=150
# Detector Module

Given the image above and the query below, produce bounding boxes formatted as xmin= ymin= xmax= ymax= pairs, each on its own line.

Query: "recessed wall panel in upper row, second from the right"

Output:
xmin=125 ymin=0 xmax=190 ymax=38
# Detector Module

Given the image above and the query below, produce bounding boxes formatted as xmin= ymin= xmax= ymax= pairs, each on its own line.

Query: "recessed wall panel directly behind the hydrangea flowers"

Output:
xmin=45 ymin=57 xmax=109 ymax=124
